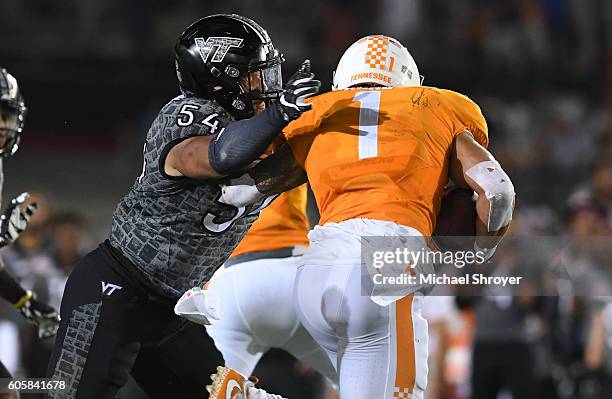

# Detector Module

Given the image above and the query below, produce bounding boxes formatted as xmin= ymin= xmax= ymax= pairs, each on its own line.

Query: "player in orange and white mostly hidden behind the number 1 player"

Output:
xmin=196 ymin=185 xmax=336 ymax=399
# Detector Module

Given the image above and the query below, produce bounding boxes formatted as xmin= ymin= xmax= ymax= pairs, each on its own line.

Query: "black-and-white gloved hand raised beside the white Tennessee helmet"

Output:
xmin=280 ymin=60 xmax=321 ymax=122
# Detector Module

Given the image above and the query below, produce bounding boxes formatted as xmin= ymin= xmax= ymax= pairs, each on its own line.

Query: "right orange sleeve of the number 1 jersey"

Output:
xmin=444 ymin=91 xmax=489 ymax=148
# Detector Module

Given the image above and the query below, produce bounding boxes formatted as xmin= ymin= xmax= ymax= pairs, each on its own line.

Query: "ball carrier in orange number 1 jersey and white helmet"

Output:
xmin=222 ymin=35 xmax=515 ymax=399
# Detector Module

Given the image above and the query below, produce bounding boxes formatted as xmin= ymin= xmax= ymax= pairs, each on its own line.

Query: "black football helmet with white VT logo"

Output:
xmin=174 ymin=14 xmax=284 ymax=119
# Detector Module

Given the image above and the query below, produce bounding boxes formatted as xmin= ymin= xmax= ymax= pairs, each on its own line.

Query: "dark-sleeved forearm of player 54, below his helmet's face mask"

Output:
xmin=208 ymin=106 xmax=287 ymax=175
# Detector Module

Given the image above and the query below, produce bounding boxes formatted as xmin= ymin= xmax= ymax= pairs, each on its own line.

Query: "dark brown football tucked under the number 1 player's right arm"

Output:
xmin=433 ymin=187 xmax=476 ymax=251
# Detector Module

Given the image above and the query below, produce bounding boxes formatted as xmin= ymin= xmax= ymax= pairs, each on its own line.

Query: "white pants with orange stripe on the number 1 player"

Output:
xmin=295 ymin=219 xmax=428 ymax=399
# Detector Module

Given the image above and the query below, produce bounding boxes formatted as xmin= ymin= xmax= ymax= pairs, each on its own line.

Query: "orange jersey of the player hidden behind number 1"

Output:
xmin=231 ymin=184 xmax=310 ymax=256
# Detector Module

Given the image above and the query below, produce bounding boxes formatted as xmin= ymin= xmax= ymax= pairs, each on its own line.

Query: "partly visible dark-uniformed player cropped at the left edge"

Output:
xmin=0 ymin=68 xmax=59 ymax=398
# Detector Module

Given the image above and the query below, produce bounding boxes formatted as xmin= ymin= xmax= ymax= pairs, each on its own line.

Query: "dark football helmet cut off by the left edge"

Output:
xmin=0 ymin=68 xmax=27 ymax=157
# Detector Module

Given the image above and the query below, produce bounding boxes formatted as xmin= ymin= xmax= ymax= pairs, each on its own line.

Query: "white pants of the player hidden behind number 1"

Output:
xmin=206 ymin=257 xmax=337 ymax=384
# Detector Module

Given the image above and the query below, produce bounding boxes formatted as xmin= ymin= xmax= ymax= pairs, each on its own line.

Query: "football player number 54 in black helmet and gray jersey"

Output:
xmin=48 ymin=14 xmax=320 ymax=399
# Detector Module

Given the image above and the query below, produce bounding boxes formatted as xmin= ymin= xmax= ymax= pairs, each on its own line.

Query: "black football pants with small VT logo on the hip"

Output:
xmin=47 ymin=248 xmax=223 ymax=399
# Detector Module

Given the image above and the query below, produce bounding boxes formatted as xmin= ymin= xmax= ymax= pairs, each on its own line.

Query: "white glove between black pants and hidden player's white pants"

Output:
xmin=174 ymin=287 xmax=219 ymax=325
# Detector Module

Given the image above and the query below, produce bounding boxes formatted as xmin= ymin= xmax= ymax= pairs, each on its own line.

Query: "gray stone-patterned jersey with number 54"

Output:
xmin=110 ymin=96 xmax=268 ymax=298
